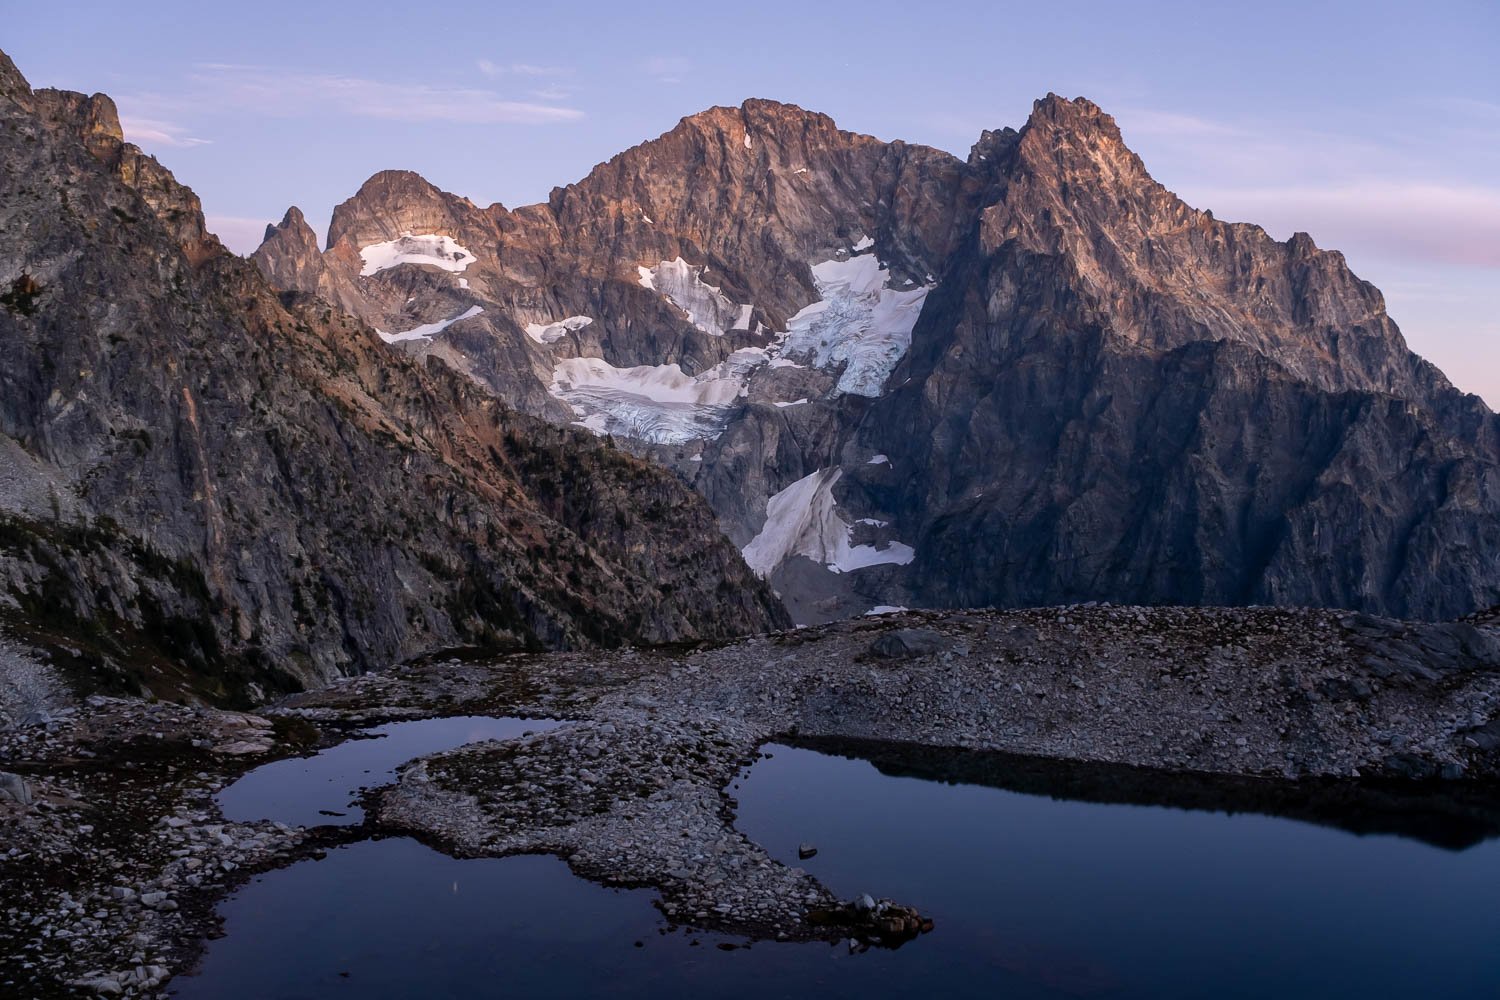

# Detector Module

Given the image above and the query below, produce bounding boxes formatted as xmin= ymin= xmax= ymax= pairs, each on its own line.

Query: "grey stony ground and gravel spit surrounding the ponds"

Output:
xmin=0 ymin=607 xmax=1500 ymax=996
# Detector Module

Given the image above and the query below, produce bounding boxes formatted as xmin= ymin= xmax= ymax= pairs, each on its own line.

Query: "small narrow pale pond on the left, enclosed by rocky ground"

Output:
xmin=219 ymin=715 xmax=563 ymax=826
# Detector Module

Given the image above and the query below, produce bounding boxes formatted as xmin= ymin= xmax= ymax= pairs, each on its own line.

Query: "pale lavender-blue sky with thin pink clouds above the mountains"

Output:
xmin=5 ymin=0 xmax=1500 ymax=406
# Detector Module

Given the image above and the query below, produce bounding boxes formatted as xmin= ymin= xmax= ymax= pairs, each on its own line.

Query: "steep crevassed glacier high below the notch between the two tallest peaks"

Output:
xmin=779 ymin=251 xmax=933 ymax=396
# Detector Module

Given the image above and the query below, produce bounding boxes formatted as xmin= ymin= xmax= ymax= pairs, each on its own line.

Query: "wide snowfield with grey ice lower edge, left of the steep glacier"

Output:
xmin=552 ymin=348 xmax=765 ymax=444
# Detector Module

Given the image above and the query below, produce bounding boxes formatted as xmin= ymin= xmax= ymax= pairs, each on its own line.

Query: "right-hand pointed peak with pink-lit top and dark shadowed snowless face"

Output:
xmin=857 ymin=99 xmax=1500 ymax=618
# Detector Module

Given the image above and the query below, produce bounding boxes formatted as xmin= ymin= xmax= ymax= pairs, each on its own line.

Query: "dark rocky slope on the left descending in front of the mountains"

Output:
xmin=0 ymin=48 xmax=785 ymax=699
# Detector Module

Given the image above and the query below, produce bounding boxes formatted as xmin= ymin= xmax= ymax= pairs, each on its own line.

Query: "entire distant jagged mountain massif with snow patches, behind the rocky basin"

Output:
xmin=257 ymin=89 xmax=1500 ymax=621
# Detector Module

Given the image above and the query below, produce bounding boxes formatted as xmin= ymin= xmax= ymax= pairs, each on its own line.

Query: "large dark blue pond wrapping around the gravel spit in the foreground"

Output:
xmin=174 ymin=723 xmax=1500 ymax=1000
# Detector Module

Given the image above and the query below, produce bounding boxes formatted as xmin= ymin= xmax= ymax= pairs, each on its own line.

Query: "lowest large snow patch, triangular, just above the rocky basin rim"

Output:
xmin=743 ymin=468 xmax=917 ymax=579
